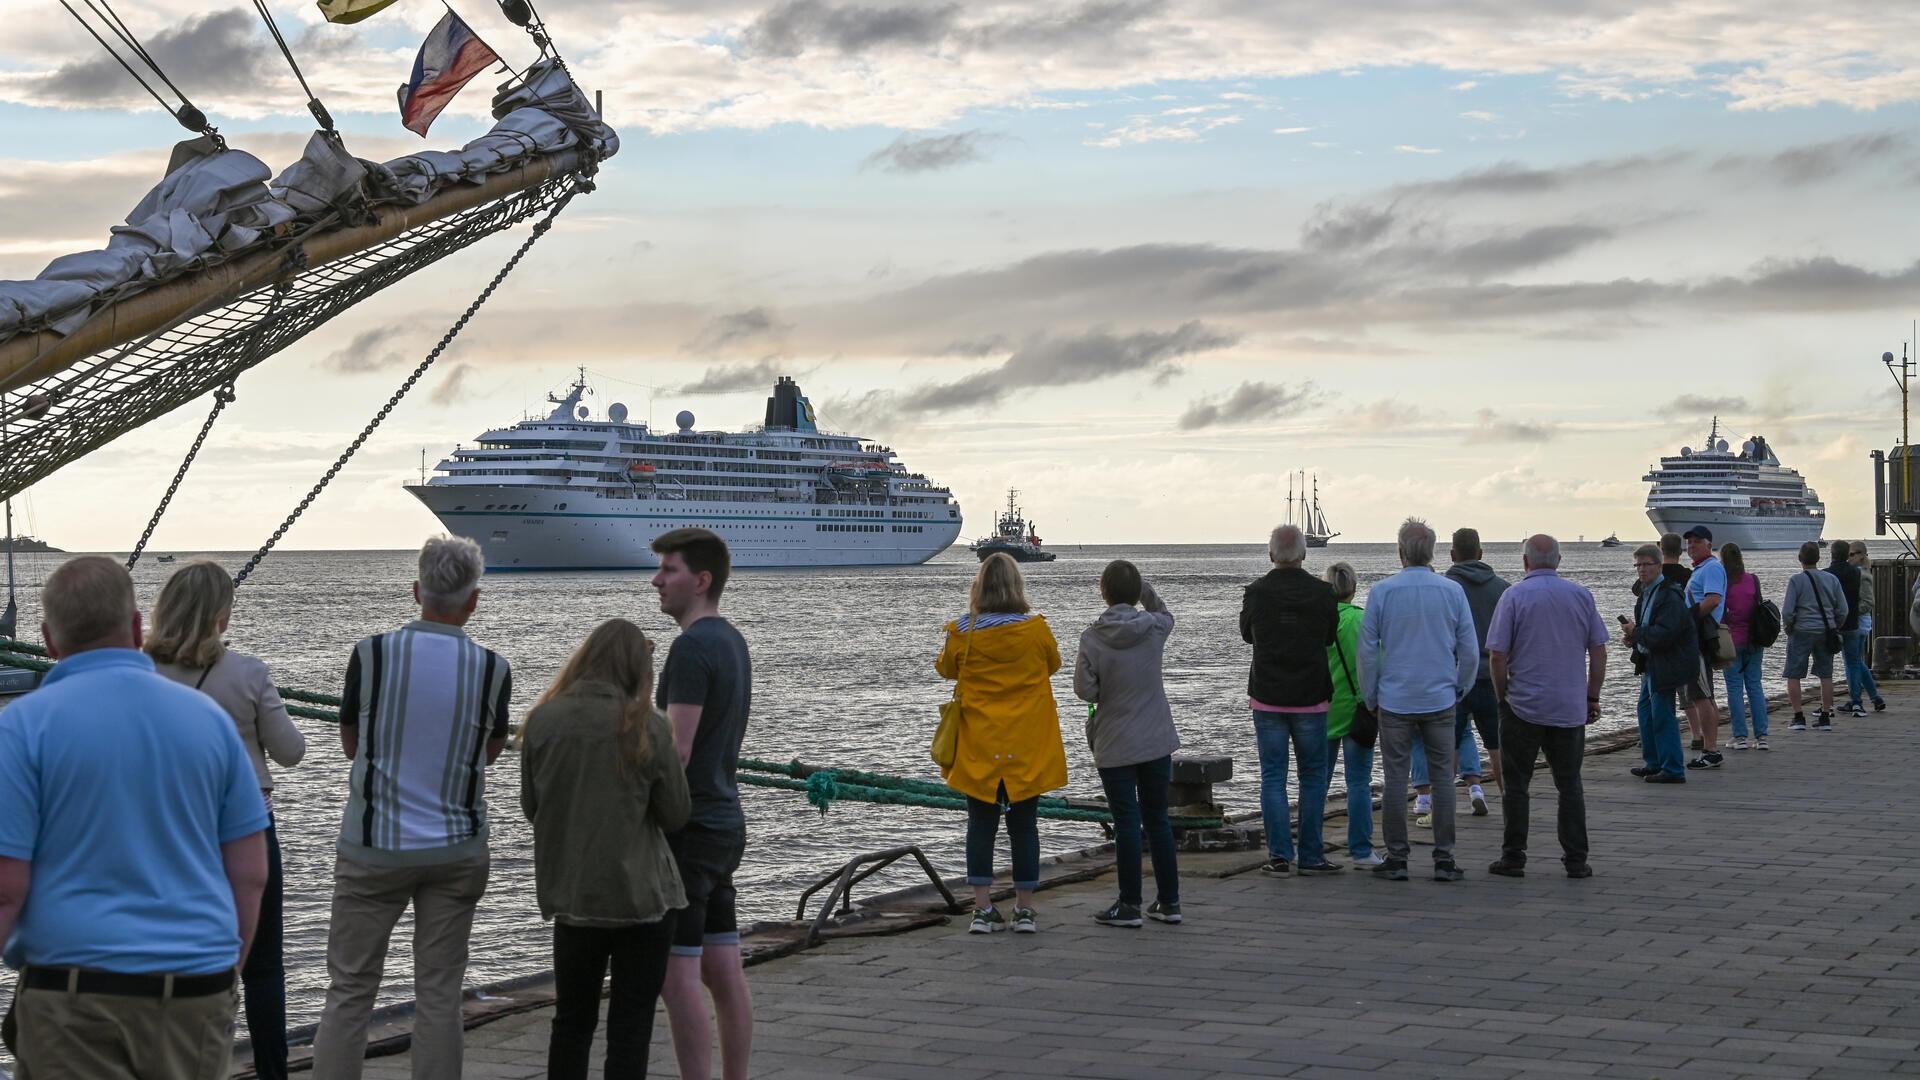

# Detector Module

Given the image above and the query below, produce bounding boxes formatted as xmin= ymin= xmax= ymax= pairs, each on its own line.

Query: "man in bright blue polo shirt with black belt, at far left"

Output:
xmin=0 ymin=555 xmax=267 ymax=1080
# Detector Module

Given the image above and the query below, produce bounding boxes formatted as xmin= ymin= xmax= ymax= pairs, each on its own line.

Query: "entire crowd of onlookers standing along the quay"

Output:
xmin=0 ymin=519 xmax=1889 ymax=1080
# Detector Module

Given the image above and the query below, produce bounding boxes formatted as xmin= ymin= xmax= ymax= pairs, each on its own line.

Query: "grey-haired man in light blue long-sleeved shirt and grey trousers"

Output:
xmin=1359 ymin=517 xmax=1480 ymax=882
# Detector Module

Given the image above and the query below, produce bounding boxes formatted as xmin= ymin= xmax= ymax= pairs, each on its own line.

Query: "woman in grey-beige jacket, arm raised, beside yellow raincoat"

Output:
xmin=1073 ymin=559 xmax=1181 ymax=928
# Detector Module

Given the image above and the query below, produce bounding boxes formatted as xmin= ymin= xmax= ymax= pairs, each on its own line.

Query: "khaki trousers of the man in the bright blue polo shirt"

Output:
xmin=13 ymin=976 xmax=238 ymax=1080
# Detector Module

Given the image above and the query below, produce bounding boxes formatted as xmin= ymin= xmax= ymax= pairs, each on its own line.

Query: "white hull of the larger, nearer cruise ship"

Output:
xmin=407 ymin=484 xmax=960 ymax=573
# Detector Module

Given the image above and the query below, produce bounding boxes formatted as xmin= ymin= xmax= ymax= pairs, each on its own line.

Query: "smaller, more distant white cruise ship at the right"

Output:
xmin=1645 ymin=417 xmax=1826 ymax=552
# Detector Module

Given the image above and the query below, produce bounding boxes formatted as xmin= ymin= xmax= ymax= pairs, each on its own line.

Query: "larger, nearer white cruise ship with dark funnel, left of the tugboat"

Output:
xmin=407 ymin=373 xmax=962 ymax=571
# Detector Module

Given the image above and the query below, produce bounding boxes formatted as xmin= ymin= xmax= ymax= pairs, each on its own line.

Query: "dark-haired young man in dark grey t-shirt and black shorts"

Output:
xmin=653 ymin=528 xmax=753 ymax=1080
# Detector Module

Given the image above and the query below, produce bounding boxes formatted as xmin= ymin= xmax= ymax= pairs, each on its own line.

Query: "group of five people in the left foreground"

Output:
xmin=0 ymin=528 xmax=753 ymax=1080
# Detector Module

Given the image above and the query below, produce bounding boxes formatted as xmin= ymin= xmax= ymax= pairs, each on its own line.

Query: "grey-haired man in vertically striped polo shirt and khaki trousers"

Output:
xmin=313 ymin=536 xmax=513 ymax=1080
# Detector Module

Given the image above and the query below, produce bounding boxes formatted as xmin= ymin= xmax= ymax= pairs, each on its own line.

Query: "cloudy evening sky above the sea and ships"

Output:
xmin=0 ymin=0 xmax=1920 ymax=550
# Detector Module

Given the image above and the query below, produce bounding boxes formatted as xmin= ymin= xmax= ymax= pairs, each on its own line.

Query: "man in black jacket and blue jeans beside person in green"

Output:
xmin=1240 ymin=525 xmax=1344 ymax=876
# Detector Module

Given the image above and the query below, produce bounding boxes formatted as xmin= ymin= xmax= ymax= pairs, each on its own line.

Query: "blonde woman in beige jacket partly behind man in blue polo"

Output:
xmin=146 ymin=561 xmax=307 ymax=1080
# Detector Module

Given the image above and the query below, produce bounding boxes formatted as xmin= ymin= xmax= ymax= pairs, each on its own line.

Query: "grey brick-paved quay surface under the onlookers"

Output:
xmin=369 ymin=682 xmax=1920 ymax=1080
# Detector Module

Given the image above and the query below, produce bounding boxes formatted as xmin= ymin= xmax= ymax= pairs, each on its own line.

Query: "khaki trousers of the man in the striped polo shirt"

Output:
xmin=313 ymin=855 xmax=488 ymax=1080
